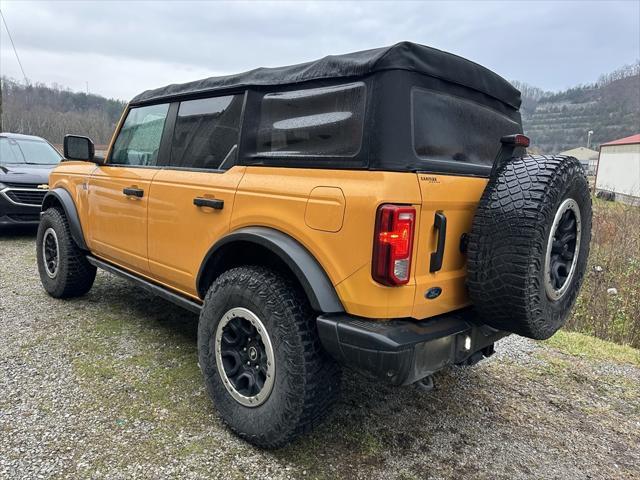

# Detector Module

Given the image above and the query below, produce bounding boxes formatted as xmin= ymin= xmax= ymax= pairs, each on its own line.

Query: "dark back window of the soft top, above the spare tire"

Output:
xmin=411 ymin=88 xmax=521 ymax=165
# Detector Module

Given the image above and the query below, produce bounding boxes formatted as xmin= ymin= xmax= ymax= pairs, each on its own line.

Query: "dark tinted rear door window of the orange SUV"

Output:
xmin=171 ymin=95 xmax=244 ymax=170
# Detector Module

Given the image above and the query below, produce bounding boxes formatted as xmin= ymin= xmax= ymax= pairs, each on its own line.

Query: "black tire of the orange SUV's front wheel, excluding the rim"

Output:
xmin=36 ymin=207 xmax=96 ymax=298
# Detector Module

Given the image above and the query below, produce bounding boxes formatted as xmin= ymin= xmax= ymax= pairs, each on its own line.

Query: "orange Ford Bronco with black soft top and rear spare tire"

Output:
xmin=37 ymin=42 xmax=591 ymax=447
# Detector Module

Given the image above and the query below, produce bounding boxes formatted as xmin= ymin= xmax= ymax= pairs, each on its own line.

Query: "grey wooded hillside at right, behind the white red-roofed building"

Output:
xmin=513 ymin=64 xmax=640 ymax=153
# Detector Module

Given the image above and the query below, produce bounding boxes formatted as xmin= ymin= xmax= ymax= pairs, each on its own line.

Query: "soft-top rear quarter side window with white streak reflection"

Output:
xmin=257 ymin=83 xmax=365 ymax=157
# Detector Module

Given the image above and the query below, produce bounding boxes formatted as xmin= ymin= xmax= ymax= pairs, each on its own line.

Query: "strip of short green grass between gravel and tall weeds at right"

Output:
xmin=544 ymin=330 xmax=640 ymax=366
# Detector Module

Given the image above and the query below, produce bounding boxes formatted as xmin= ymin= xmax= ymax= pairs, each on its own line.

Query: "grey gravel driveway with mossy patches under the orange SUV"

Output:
xmin=0 ymin=227 xmax=640 ymax=480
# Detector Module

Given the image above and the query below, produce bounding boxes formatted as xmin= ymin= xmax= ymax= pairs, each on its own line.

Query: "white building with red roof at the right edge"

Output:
xmin=596 ymin=133 xmax=640 ymax=205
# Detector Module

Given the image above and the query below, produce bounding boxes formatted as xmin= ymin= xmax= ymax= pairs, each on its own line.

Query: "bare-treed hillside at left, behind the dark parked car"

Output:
xmin=1 ymin=77 xmax=125 ymax=144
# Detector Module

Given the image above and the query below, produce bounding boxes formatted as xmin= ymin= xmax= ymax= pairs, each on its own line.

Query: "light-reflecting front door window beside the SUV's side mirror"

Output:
xmin=110 ymin=103 xmax=169 ymax=165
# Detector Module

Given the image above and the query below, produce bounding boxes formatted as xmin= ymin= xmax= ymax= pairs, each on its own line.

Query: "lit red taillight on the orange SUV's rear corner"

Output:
xmin=371 ymin=205 xmax=416 ymax=286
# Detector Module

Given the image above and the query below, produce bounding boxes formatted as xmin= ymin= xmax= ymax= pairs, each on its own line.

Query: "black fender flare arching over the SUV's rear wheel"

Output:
xmin=196 ymin=227 xmax=344 ymax=313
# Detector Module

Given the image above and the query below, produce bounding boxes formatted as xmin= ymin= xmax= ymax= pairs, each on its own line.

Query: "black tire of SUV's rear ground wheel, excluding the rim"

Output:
xmin=198 ymin=266 xmax=341 ymax=448
